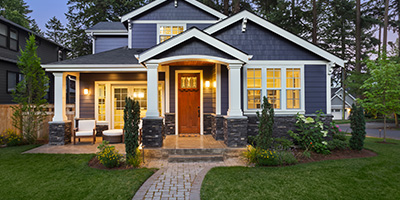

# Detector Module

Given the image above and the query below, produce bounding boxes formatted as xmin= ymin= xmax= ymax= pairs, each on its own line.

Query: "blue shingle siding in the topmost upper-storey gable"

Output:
xmin=133 ymin=0 xmax=218 ymax=20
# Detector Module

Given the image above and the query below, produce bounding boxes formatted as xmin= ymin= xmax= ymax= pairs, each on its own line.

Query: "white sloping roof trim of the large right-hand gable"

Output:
xmin=204 ymin=10 xmax=345 ymax=67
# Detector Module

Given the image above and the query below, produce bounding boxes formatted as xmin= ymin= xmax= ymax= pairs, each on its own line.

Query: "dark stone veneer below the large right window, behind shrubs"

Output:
xmin=246 ymin=114 xmax=333 ymax=138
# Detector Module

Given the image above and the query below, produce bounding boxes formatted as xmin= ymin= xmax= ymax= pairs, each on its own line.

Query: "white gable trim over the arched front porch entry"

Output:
xmin=138 ymin=27 xmax=252 ymax=63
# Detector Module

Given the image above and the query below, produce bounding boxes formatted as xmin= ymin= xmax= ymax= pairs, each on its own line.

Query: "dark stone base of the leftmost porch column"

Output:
xmin=49 ymin=121 xmax=72 ymax=145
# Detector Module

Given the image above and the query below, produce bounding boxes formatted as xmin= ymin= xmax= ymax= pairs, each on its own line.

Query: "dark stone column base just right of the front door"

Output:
xmin=224 ymin=116 xmax=247 ymax=147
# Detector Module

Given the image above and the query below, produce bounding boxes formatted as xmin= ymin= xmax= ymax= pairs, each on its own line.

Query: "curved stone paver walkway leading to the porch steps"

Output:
xmin=133 ymin=159 xmax=245 ymax=200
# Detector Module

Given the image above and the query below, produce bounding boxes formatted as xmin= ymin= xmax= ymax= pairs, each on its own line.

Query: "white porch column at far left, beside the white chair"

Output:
xmin=53 ymin=72 xmax=67 ymax=122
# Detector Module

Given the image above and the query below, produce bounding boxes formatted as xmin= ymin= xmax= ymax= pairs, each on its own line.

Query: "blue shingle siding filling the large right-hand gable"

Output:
xmin=213 ymin=21 xmax=324 ymax=60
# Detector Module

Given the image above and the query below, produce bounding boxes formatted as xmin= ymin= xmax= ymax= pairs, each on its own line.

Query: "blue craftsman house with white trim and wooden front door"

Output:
xmin=43 ymin=0 xmax=344 ymax=147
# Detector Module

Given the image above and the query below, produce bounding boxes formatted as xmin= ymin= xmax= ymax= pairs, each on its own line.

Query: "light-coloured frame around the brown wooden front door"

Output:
xmin=175 ymin=70 xmax=204 ymax=135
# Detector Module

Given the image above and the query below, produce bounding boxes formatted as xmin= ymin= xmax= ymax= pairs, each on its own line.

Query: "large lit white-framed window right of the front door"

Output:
xmin=244 ymin=66 xmax=304 ymax=113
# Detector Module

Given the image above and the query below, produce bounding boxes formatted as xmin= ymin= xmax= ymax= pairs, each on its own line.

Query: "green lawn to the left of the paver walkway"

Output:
xmin=0 ymin=146 xmax=154 ymax=200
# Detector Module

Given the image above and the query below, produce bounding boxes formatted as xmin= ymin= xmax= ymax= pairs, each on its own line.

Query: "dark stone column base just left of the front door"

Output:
xmin=142 ymin=118 xmax=163 ymax=147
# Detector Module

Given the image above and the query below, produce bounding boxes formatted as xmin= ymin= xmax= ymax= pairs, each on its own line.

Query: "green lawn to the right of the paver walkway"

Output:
xmin=201 ymin=138 xmax=400 ymax=200
